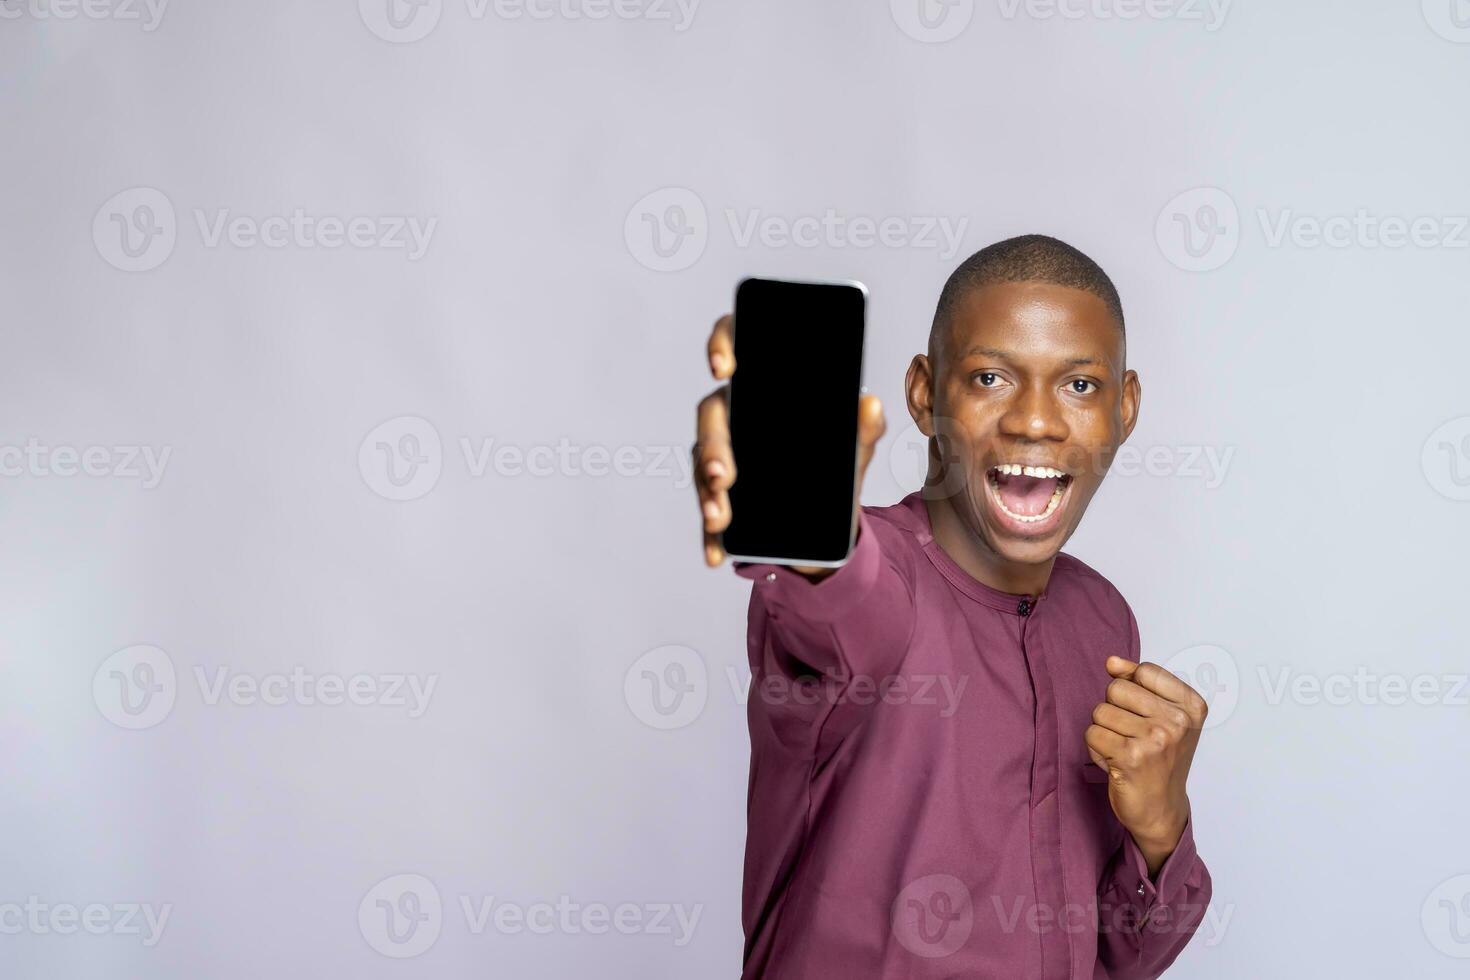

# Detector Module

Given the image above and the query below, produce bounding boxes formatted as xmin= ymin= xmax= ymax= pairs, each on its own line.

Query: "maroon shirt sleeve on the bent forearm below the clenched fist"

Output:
xmin=1098 ymin=818 xmax=1213 ymax=980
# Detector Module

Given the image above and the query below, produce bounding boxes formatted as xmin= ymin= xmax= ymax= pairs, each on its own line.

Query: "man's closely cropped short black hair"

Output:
xmin=929 ymin=235 xmax=1125 ymax=354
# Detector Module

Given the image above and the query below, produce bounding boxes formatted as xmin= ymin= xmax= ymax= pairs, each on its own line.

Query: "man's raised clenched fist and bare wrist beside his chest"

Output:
xmin=1085 ymin=657 xmax=1208 ymax=876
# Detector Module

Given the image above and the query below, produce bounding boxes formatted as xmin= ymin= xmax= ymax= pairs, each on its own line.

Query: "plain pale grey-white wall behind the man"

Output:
xmin=0 ymin=0 xmax=1470 ymax=979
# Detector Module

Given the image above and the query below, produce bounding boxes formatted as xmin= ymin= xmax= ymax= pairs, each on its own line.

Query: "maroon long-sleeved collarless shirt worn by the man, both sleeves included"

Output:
xmin=736 ymin=494 xmax=1210 ymax=980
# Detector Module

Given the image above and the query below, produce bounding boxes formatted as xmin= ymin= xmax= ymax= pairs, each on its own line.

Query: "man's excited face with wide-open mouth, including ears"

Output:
xmin=908 ymin=282 xmax=1139 ymax=564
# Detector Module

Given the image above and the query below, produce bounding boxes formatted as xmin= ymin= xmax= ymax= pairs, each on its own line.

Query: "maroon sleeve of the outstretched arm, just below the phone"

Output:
xmin=735 ymin=511 xmax=914 ymax=708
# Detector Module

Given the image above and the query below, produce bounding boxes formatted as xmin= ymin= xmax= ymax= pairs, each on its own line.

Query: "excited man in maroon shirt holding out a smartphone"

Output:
xmin=695 ymin=235 xmax=1210 ymax=980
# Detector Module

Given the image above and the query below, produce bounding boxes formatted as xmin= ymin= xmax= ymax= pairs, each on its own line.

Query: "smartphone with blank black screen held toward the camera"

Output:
xmin=723 ymin=279 xmax=867 ymax=567
